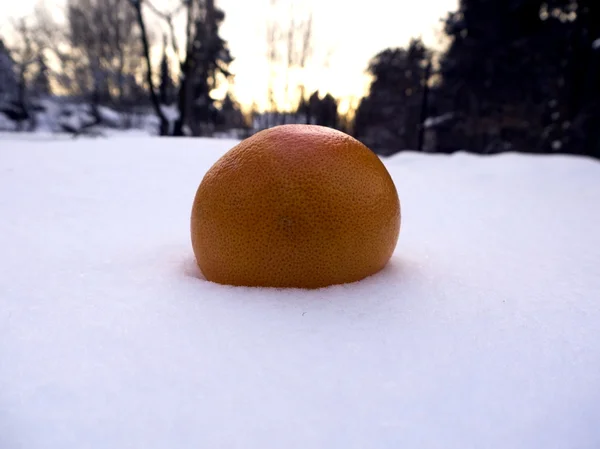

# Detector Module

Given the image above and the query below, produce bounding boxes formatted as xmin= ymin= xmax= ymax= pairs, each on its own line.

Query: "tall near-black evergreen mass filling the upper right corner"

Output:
xmin=438 ymin=0 xmax=600 ymax=158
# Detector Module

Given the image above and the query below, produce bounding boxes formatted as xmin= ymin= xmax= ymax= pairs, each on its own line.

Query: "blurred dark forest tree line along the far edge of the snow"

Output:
xmin=0 ymin=0 xmax=600 ymax=158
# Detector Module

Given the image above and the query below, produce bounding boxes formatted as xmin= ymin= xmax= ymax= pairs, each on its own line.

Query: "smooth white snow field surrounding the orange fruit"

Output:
xmin=0 ymin=136 xmax=600 ymax=449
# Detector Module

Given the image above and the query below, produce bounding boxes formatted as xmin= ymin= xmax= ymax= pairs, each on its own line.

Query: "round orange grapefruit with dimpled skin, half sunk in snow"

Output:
xmin=191 ymin=125 xmax=400 ymax=288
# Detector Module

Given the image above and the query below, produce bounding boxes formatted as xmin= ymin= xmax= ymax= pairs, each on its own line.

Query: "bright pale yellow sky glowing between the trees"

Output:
xmin=0 ymin=0 xmax=458 ymax=110
